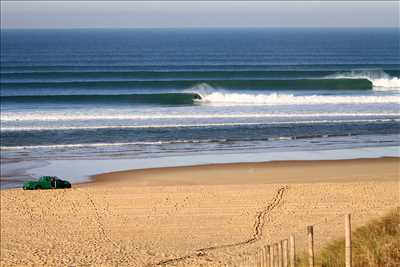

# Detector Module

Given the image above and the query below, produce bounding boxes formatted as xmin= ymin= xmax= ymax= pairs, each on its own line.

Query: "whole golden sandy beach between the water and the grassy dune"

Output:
xmin=1 ymin=158 xmax=400 ymax=266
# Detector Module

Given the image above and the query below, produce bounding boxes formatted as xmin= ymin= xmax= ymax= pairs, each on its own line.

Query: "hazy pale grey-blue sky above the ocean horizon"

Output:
xmin=1 ymin=0 xmax=400 ymax=29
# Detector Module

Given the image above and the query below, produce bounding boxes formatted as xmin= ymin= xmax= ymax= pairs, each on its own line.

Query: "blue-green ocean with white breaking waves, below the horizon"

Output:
xmin=0 ymin=28 xmax=400 ymax=186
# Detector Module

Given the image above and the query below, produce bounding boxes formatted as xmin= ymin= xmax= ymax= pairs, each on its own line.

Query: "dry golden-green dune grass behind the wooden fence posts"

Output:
xmin=297 ymin=207 xmax=400 ymax=267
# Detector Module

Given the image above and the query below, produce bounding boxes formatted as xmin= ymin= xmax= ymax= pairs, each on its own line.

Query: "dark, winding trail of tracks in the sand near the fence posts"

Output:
xmin=152 ymin=186 xmax=289 ymax=266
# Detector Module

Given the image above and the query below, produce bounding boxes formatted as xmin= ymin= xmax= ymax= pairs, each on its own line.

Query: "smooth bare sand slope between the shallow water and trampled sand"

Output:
xmin=89 ymin=157 xmax=400 ymax=186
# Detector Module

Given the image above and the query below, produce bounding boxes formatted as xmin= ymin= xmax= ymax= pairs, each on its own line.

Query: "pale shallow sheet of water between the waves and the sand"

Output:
xmin=0 ymin=146 xmax=400 ymax=190
